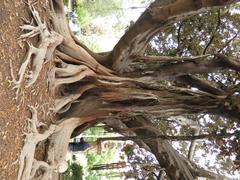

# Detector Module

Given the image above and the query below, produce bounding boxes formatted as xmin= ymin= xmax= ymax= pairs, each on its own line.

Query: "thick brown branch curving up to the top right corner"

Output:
xmin=110 ymin=0 xmax=234 ymax=72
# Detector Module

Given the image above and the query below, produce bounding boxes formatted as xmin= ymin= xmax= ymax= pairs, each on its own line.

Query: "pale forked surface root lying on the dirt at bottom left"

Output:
xmin=17 ymin=106 xmax=58 ymax=180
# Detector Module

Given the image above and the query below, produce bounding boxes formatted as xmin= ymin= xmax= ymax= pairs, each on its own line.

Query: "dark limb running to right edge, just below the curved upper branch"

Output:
xmin=129 ymin=54 xmax=240 ymax=80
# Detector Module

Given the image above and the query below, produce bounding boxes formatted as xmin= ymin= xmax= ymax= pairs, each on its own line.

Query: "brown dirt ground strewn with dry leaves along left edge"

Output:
xmin=0 ymin=0 xmax=53 ymax=180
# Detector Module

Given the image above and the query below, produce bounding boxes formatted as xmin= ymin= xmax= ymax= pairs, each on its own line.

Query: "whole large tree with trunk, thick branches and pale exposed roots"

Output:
xmin=12 ymin=0 xmax=240 ymax=180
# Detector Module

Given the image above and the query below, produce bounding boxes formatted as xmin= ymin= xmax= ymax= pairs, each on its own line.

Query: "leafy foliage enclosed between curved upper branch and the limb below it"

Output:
xmin=148 ymin=7 xmax=240 ymax=56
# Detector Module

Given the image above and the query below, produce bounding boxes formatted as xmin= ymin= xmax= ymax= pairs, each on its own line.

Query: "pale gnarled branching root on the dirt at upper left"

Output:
xmin=11 ymin=2 xmax=63 ymax=98
